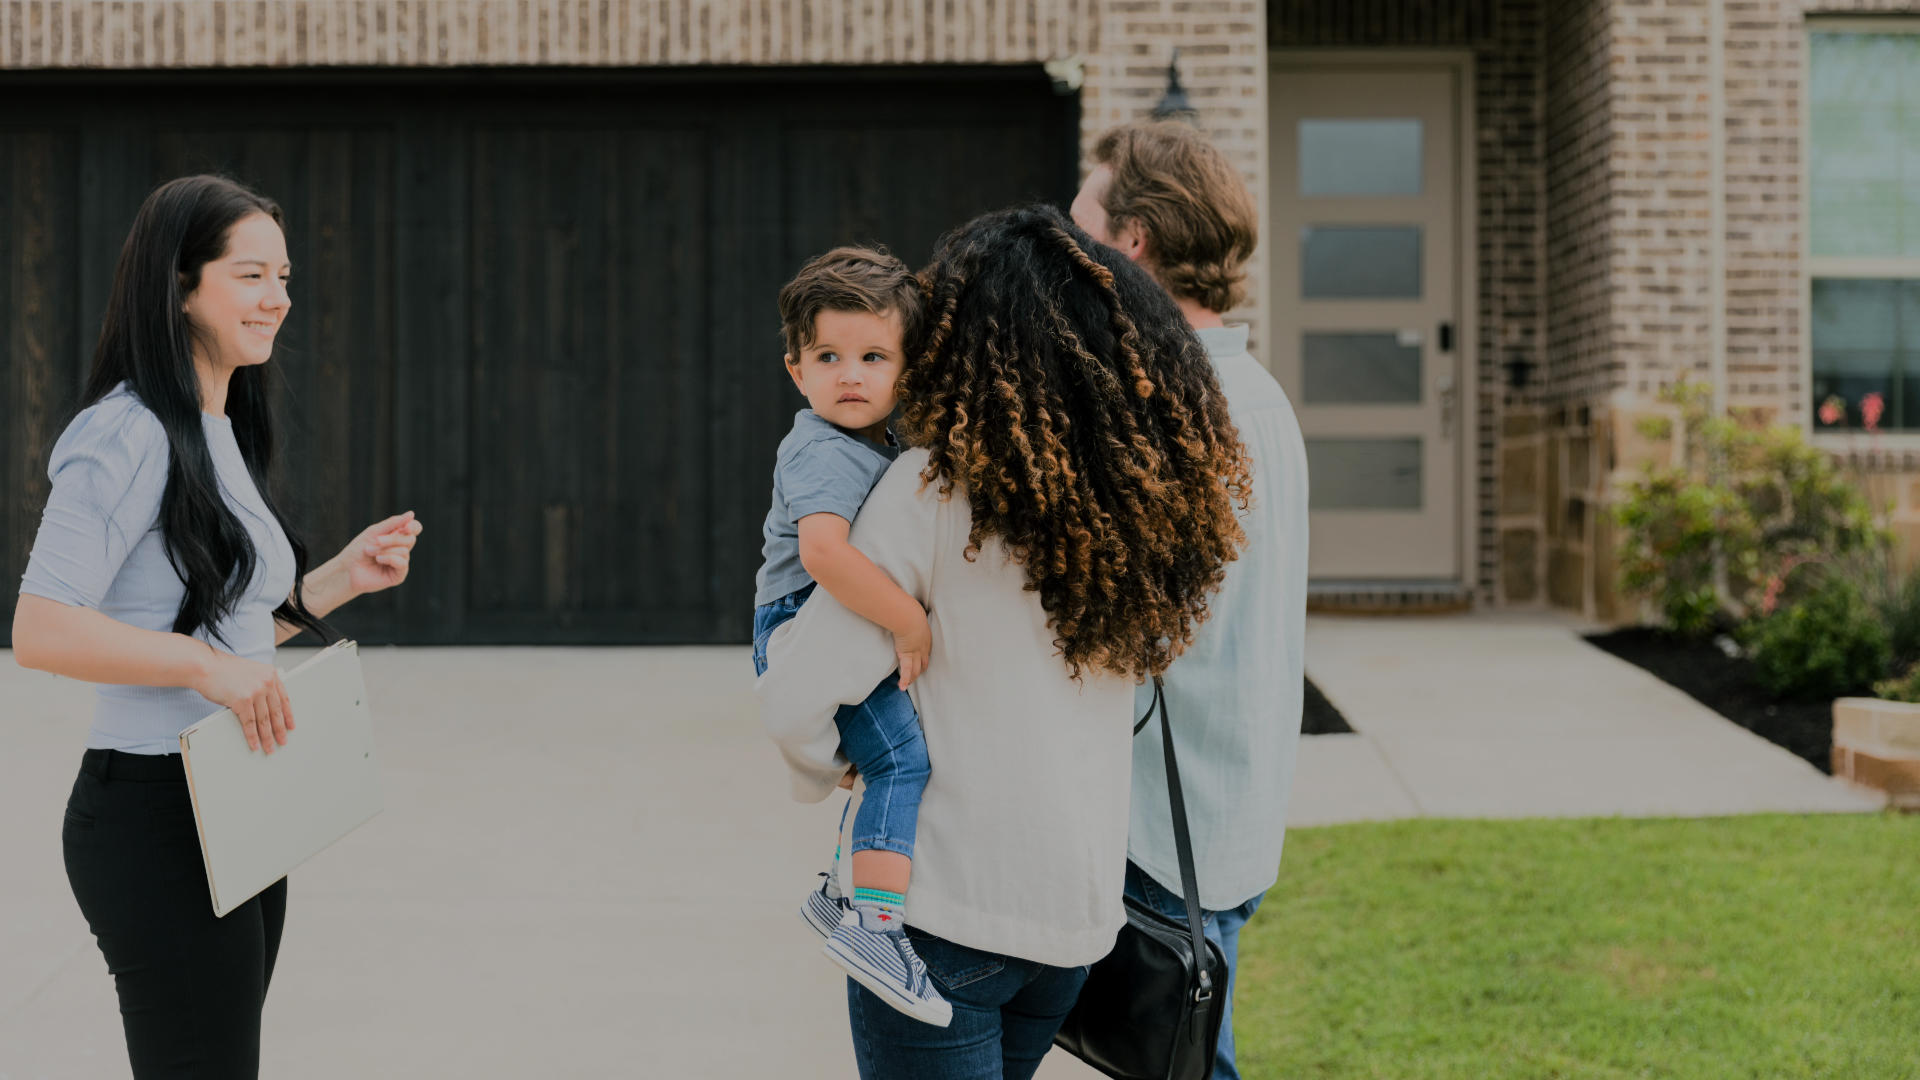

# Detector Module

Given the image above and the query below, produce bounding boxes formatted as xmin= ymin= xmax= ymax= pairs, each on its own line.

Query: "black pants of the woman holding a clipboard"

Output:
xmin=61 ymin=749 xmax=286 ymax=1080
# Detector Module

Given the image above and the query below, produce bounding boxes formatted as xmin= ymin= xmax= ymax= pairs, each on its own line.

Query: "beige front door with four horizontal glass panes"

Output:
xmin=1267 ymin=63 xmax=1465 ymax=582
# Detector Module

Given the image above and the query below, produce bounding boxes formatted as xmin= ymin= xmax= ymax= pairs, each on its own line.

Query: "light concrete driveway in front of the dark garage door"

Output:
xmin=0 ymin=648 xmax=1021 ymax=1080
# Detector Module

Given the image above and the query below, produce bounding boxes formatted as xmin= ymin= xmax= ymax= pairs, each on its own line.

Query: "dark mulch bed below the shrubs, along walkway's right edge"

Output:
xmin=1588 ymin=626 xmax=1834 ymax=773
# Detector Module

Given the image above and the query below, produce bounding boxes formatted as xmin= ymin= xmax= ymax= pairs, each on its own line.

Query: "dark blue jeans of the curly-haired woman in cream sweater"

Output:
xmin=847 ymin=926 xmax=1087 ymax=1080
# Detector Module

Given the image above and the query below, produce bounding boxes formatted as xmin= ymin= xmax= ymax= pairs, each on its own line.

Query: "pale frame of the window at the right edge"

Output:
xmin=1799 ymin=13 xmax=1920 ymax=441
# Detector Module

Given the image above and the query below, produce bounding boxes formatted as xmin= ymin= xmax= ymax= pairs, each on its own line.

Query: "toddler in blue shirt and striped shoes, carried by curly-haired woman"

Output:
xmin=753 ymin=248 xmax=952 ymax=1028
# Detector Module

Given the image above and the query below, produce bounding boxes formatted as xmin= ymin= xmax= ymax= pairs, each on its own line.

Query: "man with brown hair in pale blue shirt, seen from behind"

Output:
xmin=1073 ymin=123 xmax=1308 ymax=1080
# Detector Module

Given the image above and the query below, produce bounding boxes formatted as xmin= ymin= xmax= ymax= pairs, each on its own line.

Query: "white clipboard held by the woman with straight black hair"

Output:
xmin=180 ymin=642 xmax=380 ymax=917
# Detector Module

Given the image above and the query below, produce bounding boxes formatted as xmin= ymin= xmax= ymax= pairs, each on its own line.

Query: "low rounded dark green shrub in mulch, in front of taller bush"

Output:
xmin=1749 ymin=573 xmax=1893 ymax=700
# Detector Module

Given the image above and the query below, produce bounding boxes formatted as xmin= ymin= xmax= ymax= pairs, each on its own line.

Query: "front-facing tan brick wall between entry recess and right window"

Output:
xmin=1589 ymin=0 xmax=1920 ymax=423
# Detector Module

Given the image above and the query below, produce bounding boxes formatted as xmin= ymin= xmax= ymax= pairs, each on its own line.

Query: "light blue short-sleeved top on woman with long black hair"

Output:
xmin=19 ymin=382 xmax=294 ymax=753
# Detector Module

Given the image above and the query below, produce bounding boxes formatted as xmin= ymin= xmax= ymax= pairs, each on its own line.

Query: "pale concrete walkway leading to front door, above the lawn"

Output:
xmin=1288 ymin=615 xmax=1882 ymax=826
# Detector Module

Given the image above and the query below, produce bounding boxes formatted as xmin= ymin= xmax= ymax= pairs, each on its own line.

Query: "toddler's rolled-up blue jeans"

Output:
xmin=753 ymin=586 xmax=931 ymax=857
